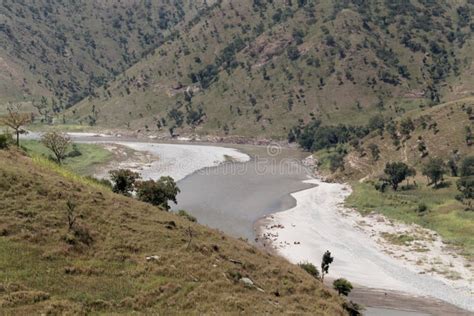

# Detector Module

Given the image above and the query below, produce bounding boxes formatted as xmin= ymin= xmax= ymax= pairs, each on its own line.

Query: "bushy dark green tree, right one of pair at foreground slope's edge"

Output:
xmin=137 ymin=177 xmax=180 ymax=211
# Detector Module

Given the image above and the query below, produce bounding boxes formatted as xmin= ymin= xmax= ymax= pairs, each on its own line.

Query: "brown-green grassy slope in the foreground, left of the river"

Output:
xmin=0 ymin=150 xmax=344 ymax=315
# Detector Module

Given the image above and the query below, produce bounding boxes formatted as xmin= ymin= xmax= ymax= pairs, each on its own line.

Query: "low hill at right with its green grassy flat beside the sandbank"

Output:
xmin=315 ymin=97 xmax=474 ymax=261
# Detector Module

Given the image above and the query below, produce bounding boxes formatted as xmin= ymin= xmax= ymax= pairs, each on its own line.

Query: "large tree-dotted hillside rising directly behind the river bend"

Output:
xmin=69 ymin=0 xmax=474 ymax=137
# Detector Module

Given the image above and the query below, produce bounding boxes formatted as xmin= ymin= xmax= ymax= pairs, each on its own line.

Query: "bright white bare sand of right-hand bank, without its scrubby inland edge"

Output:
xmin=260 ymin=179 xmax=474 ymax=311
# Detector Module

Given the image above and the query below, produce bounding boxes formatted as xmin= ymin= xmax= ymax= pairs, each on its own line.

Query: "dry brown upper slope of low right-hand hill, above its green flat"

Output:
xmin=346 ymin=98 xmax=474 ymax=179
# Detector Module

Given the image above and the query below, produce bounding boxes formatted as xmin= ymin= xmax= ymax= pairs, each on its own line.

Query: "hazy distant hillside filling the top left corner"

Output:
xmin=0 ymin=0 xmax=212 ymax=107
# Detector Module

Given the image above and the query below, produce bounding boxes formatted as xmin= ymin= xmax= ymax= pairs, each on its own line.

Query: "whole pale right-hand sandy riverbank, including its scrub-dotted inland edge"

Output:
xmin=260 ymin=179 xmax=474 ymax=311
